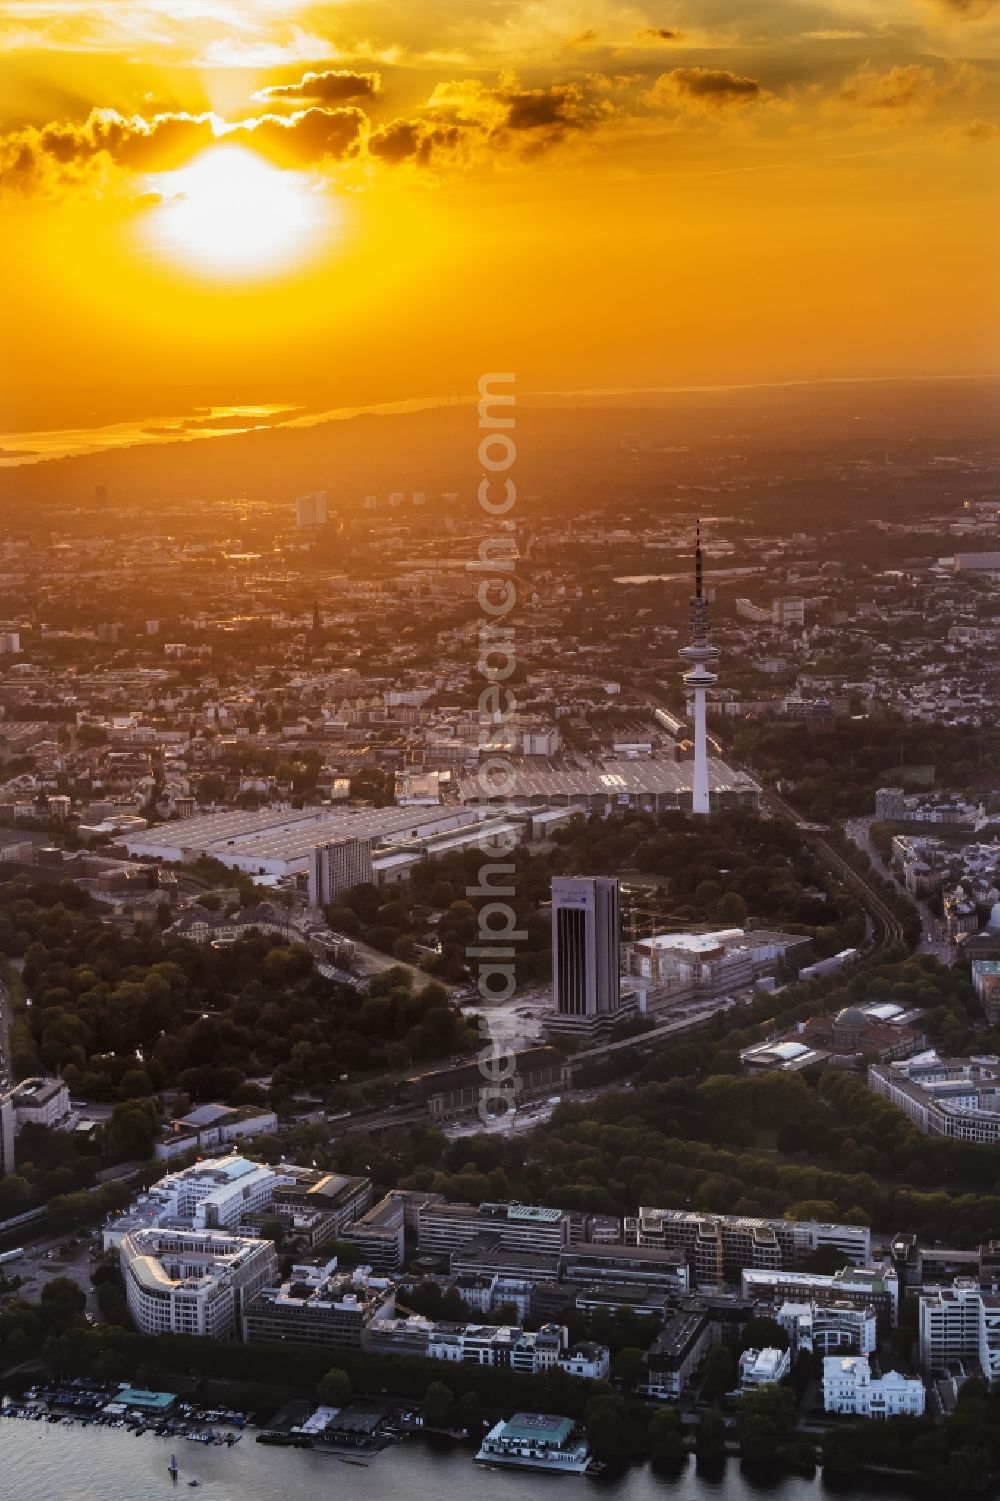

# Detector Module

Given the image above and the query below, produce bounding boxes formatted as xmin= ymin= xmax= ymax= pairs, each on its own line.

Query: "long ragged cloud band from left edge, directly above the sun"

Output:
xmin=0 ymin=105 xmax=368 ymax=191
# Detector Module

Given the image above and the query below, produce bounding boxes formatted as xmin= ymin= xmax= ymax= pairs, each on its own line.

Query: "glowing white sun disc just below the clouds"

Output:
xmin=144 ymin=146 xmax=333 ymax=278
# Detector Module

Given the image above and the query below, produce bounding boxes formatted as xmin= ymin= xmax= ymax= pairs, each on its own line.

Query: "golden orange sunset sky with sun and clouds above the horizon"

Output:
xmin=0 ymin=0 xmax=1000 ymax=452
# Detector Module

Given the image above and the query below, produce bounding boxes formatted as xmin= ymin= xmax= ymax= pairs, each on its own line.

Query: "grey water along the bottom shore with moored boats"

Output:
xmin=0 ymin=1418 xmax=911 ymax=1501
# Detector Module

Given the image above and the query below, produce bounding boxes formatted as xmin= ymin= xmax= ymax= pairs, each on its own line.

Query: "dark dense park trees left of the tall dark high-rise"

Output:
xmin=0 ymin=881 xmax=474 ymax=1110
